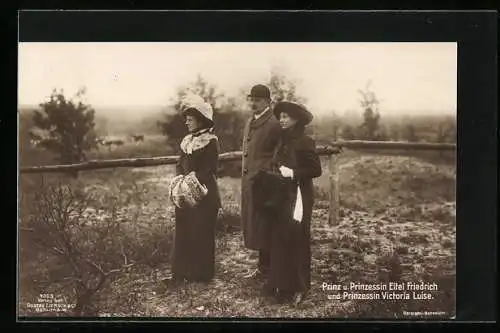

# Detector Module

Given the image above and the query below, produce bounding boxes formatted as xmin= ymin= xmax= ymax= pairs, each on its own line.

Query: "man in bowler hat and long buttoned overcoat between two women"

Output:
xmin=241 ymin=85 xmax=281 ymax=277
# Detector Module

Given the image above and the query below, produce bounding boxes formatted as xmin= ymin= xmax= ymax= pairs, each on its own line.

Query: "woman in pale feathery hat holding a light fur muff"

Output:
xmin=170 ymin=95 xmax=221 ymax=283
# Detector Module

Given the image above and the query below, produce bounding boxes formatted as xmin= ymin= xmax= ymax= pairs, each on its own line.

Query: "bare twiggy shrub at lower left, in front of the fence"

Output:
xmin=20 ymin=174 xmax=172 ymax=316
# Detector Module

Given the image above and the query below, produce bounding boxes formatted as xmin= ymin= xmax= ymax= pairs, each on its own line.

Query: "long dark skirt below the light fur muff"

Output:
xmin=171 ymin=205 xmax=218 ymax=282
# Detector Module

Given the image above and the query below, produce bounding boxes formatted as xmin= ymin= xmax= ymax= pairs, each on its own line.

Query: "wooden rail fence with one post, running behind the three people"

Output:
xmin=19 ymin=141 xmax=456 ymax=225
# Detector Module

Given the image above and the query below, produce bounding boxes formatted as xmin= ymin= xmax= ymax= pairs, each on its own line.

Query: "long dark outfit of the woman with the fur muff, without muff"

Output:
xmin=172 ymin=130 xmax=221 ymax=281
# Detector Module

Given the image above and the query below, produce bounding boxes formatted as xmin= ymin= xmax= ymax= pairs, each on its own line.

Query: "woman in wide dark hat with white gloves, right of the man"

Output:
xmin=267 ymin=102 xmax=322 ymax=303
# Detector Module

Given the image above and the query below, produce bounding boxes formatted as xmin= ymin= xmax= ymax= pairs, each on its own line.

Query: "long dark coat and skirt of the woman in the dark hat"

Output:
xmin=260 ymin=127 xmax=322 ymax=292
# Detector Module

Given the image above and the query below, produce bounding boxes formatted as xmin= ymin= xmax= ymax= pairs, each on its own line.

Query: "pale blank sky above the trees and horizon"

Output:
xmin=18 ymin=43 xmax=457 ymax=113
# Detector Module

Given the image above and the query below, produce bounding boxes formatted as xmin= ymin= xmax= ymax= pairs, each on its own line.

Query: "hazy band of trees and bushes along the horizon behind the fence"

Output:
xmin=20 ymin=71 xmax=456 ymax=174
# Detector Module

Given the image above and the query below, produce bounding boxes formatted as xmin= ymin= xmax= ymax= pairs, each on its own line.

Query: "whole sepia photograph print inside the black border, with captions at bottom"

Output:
xmin=17 ymin=42 xmax=457 ymax=320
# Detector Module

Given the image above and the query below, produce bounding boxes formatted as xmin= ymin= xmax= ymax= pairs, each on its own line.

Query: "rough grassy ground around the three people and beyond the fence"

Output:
xmin=20 ymin=139 xmax=456 ymax=319
